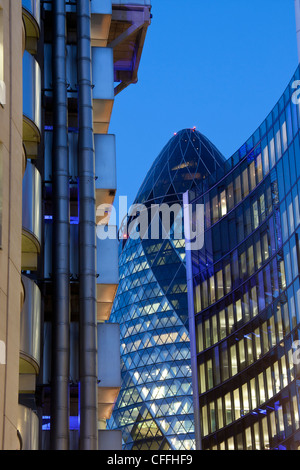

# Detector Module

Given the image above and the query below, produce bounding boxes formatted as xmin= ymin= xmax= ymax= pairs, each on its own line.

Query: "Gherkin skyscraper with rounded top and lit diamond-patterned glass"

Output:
xmin=109 ymin=129 xmax=225 ymax=450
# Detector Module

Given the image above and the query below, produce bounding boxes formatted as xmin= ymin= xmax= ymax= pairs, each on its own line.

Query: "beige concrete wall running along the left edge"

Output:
xmin=0 ymin=0 xmax=25 ymax=450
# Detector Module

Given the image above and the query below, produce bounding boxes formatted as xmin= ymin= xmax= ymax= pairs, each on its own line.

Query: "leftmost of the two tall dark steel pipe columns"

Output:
xmin=51 ymin=0 xmax=70 ymax=450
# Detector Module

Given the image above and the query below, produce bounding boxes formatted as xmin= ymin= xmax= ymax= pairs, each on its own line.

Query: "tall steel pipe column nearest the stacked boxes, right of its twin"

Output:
xmin=77 ymin=0 xmax=98 ymax=450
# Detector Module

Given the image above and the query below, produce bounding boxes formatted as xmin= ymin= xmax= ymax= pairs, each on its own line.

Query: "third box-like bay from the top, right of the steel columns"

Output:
xmin=94 ymin=134 xmax=117 ymax=224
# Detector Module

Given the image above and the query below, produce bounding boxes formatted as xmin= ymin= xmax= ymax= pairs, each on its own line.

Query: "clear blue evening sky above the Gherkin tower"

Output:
xmin=109 ymin=0 xmax=298 ymax=215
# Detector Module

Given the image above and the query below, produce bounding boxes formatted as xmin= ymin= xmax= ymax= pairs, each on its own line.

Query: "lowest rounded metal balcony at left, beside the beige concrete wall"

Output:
xmin=17 ymin=405 xmax=39 ymax=450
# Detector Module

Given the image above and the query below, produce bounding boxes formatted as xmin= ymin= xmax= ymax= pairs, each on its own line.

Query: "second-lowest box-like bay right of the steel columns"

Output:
xmin=97 ymin=323 xmax=121 ymax=420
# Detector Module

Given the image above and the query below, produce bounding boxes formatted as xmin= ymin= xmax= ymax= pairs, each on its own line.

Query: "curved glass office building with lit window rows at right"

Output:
xmin=190 ymin=64 xmax=300 ymax=450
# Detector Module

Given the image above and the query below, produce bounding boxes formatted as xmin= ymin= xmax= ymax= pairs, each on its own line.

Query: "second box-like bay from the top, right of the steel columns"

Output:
xmin=92 ymin=47 xmax=115 ymax=134
